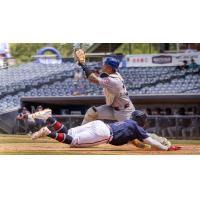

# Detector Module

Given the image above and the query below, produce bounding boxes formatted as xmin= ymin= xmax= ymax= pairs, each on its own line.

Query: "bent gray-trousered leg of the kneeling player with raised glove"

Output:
xmin=82 ymin=105 xmax=115 ymax=125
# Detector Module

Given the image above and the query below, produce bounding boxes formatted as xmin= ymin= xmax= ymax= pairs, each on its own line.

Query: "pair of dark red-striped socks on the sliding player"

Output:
xmin=47 ymin=117 xmax=73 ymax=144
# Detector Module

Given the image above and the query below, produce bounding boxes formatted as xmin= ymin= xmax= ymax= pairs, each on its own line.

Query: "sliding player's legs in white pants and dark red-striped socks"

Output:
xmin=32 ymin=117 xmax=111 ymax=147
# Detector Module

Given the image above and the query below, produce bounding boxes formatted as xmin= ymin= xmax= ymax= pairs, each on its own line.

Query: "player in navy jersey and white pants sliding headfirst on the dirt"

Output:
xmin=27 ymin=109 xmax=178 ymax=150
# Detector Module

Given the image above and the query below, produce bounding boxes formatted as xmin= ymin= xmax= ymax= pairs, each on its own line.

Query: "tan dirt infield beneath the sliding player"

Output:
xmin=0 ymin=135 xmax=200 ymax=155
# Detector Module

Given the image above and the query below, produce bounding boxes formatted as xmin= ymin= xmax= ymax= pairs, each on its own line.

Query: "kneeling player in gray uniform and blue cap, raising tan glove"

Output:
xmin=74 ymin=48 xmax=135 ymax=124
